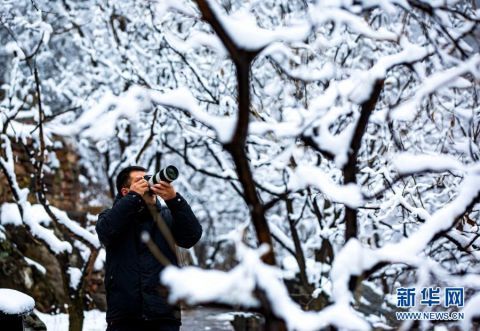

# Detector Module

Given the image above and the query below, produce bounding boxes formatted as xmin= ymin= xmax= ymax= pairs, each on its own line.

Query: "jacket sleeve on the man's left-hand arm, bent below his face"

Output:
xmin=96 ymin=191 xmax=145 ymax=246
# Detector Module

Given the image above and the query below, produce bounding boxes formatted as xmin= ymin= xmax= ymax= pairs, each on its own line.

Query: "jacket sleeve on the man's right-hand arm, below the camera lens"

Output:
xmin=165 ymin=193 xmax=203 ymax=248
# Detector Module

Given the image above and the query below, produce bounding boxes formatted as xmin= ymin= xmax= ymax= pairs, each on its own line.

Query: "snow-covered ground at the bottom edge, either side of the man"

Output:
xmin=36 ymin=307 xmax=233 ymax=331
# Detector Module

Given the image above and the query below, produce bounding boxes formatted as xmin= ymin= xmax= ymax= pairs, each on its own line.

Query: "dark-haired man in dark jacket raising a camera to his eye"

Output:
xmin=96 ymin=166 xmax=202 ymax=331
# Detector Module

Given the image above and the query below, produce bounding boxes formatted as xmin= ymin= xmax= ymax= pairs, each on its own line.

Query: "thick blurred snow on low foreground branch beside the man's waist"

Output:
xmin=161 ymin=231 xmax=370 ymax=331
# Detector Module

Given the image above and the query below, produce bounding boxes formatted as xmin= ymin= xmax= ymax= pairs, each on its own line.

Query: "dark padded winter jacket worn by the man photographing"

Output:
xmin=96 ymin=192 xmax=202 ymax=324
